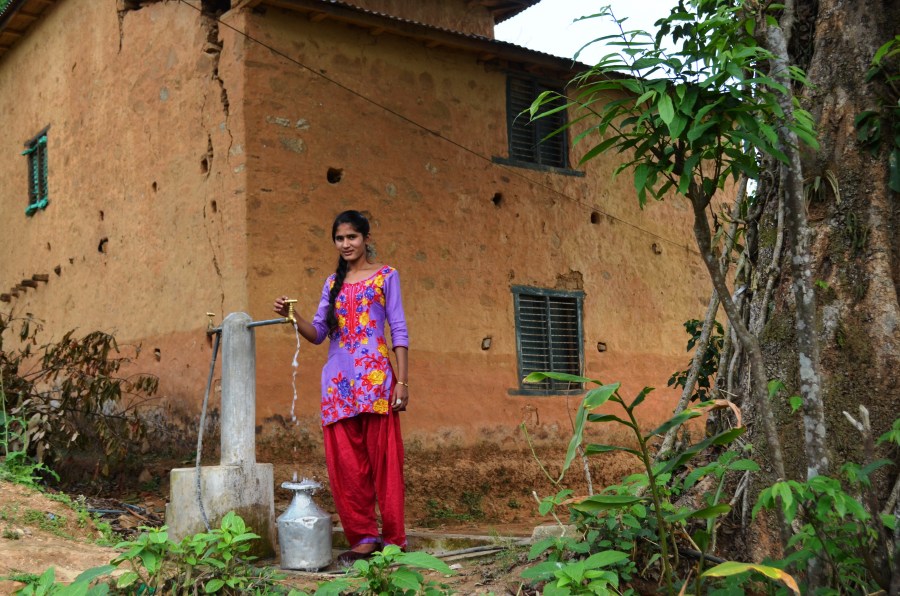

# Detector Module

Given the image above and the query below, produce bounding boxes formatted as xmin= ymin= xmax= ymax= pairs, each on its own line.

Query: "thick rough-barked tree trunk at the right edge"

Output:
xmin=754 ymin=0 xmax=900 ymax=512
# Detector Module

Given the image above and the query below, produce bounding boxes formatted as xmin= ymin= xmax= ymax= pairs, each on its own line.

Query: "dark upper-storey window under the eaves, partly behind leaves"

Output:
xmin=506 ymin=75 xmax=569 ymax=168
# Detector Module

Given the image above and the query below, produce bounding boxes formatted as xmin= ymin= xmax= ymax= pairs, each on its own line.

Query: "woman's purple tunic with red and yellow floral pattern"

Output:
xmin=312 ymin=266 xmax=409 ymax=426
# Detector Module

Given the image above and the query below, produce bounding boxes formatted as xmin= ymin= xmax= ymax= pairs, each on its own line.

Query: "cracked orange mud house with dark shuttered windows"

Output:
xmin=0 ymin=0 xmax=709 ymax=456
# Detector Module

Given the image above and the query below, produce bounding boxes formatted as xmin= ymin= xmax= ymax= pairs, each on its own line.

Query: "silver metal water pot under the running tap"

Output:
xmin=278 ymin=478 xmax=332 ymax=571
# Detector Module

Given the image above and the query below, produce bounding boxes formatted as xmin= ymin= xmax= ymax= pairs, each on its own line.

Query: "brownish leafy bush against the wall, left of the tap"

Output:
xmin=0 ymin=313 xmax=158 ymax=471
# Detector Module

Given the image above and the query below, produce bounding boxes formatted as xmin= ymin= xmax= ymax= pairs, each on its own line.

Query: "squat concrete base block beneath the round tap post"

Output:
xmin=166 ymin=464 xmax=276 ymax=558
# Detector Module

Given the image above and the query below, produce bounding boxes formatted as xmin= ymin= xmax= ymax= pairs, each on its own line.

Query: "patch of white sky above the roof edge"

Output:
xmin=494 ymin=0 xmax=675 ymax=64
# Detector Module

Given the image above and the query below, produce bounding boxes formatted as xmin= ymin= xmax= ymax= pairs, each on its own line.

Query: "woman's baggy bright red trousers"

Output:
xmin=322 ymin=410 xmax=406 ymax=548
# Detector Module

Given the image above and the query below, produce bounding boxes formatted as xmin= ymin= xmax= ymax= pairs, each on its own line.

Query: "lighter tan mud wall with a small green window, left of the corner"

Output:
xmin=0 ymin=0 xmax=247 ymax=411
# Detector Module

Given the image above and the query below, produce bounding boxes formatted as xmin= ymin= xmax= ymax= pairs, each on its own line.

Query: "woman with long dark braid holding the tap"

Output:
xmin=274 ymin=211 xmax=409 ymax=563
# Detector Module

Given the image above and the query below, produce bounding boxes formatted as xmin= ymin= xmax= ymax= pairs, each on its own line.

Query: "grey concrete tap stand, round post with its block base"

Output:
xmin=166 ymin=313 xmax=275 ymax=558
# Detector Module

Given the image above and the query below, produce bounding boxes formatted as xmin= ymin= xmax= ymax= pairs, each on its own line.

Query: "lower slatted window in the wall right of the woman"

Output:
xmin=512 ymin=286 xmax=584 ymax=395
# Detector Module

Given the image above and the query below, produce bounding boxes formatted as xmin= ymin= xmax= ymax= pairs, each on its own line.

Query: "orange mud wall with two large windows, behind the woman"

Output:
xmin=243 ymin=5 xmax=709 ymax=443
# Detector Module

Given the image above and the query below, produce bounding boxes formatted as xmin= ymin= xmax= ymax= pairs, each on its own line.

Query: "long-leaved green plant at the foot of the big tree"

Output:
xmin=523 ymin=372 xmax=793 ymax=594
